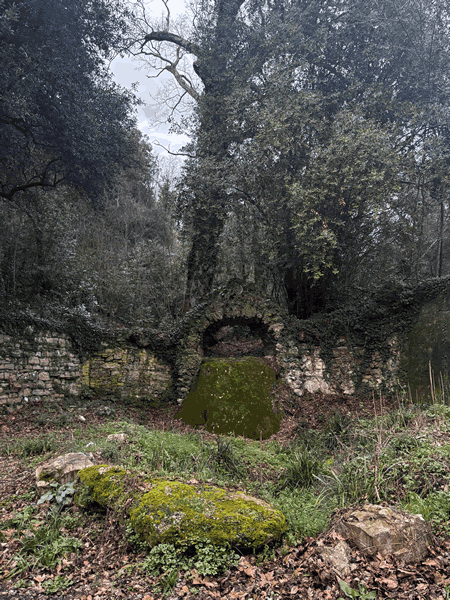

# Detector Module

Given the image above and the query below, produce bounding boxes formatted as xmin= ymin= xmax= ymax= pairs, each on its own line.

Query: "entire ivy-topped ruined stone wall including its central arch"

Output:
xmin=0 ymin=278 xmax=450 ymax=404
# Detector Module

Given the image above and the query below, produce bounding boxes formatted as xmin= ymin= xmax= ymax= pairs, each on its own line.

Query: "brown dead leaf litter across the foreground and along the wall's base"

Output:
xmin=0 ymin=396 xmax=450 ymax=600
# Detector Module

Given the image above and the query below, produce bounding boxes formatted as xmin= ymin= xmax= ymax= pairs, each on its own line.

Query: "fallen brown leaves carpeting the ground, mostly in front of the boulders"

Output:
xmin=4 ymin=397 xmax=450 ymax=600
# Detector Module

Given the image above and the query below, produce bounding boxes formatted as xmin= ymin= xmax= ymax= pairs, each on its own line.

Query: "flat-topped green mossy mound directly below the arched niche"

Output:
xmin=175 ymin=357 xmax=281 ymax=439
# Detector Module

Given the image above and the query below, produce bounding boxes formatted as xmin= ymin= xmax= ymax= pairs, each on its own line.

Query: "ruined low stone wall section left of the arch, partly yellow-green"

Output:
xmin=0 ymin=330 xmax=171 ymax=404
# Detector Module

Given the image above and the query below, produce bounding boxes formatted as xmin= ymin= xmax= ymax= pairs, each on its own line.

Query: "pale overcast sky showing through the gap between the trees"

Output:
xmin=111 ymin=0 xmax=189 ymax=154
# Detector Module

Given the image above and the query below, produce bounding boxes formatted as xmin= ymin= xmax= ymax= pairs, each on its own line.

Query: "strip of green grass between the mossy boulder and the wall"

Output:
xmin=55 ymin=398 xmax=450 ymax=541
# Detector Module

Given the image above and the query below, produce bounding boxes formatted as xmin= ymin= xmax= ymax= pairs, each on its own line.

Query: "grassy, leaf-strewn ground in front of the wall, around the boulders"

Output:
xmin=0 ymin=396 xmax=450 ymax=600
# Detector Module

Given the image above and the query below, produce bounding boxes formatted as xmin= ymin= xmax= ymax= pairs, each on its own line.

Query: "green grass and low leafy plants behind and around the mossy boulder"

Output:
xmin=4 ymin=392 xmax=450 ymax=592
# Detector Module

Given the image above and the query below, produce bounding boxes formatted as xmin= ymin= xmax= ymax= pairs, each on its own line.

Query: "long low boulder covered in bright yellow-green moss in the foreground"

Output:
xmin=79 ymin=465 xmax=286 ymax=549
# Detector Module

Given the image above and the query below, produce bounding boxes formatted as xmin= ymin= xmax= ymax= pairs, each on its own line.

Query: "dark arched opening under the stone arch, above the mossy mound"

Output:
xmin=203 ymin=317 xmax=276 ymax=357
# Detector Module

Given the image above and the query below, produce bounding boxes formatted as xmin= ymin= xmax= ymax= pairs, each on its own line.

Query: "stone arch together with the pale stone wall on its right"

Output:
xmin=175 ymin=285 xmax=400 ymax=404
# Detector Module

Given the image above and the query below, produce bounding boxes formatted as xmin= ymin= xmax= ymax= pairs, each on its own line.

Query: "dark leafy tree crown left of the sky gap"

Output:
xmin=0 ymin=0 xmax=136 ymax=200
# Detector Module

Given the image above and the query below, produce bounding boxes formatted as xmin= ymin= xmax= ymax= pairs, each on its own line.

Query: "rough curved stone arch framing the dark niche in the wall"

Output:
xmin=175 ymin=283 xmax=287 ymax=404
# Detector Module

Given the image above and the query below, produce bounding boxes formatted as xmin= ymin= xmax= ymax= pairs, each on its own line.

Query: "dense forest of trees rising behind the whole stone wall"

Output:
xmin=0 ymin=0 xmax=450 ymax=327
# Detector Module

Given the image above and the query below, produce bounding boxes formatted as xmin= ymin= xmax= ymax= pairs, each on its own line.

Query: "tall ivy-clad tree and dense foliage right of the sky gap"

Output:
xmin=127 ymin=0 xmax=450 ymax=316
